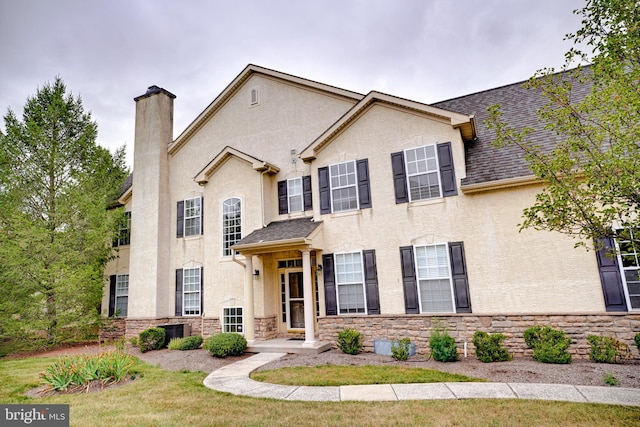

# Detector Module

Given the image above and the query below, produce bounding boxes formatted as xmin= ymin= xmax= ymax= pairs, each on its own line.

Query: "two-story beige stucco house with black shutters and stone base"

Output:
xmin=103 ymin=65 xmax=640 ymax=350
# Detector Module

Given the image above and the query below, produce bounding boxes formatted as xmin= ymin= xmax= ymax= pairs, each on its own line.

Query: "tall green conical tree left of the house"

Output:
xmin=0 ymin=77 xmax=127 ymax=343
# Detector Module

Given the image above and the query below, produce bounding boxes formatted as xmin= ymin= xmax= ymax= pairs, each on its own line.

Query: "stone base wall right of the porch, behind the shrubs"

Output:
xmin=318 ymin=313 xmax=640 ymax=359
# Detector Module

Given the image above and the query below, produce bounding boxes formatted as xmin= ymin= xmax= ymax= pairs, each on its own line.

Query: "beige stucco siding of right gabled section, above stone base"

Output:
xmin=312 ymin=106 xmax=604 ymax=314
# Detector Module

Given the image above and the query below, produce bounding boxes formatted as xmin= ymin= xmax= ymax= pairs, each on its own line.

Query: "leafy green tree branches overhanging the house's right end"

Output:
xmin=485 ymin=0 xmax=640 ymax=245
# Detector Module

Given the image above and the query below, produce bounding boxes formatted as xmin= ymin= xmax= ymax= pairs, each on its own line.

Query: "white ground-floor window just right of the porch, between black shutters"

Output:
xmin=335 ymin=252 xmax=367 ymax=314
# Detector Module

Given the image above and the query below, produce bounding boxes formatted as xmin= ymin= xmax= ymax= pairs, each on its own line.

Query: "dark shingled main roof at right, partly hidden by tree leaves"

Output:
xmin=431 ymin=68 xmax=591 ymax=185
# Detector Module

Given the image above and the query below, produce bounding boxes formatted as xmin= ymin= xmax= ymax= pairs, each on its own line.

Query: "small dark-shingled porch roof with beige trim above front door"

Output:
xmin=231 ymin=218 xmax=322 ymax=255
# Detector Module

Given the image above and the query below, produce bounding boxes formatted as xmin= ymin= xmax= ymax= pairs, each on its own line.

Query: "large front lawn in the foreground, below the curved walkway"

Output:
xmin=0 ymin=358 xmax=640 ymax=427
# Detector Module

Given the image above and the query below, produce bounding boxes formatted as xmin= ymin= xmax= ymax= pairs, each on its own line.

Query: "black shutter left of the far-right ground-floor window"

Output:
xmin=596 ymin=237 xmax=627 ymax=311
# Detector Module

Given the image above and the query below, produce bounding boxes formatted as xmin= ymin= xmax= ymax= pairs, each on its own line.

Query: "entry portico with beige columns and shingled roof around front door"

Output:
xmin=232 ymin=217 xmax=323 ymax=345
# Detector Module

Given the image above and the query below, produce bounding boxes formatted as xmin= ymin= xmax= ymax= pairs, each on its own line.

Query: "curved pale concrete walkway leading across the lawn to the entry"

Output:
xmin=204 ymin=353 xmax=640 ymax=406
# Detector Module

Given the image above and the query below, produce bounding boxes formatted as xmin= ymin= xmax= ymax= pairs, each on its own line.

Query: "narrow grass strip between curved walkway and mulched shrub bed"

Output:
xmin=251 ymin=365 xmax=484 ymax=386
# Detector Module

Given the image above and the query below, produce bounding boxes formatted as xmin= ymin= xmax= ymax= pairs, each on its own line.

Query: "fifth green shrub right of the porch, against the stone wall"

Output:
xmin=524 ymin=325 xmax=571 ymax=363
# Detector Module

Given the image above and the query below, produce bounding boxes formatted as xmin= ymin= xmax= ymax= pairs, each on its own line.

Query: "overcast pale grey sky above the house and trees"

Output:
xmin=0 ymin=0 xmax=585 ymax=165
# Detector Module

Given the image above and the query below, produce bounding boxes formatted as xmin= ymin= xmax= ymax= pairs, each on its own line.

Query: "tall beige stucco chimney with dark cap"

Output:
xmin=128 ymin=86 xmax=175 ymax=318
